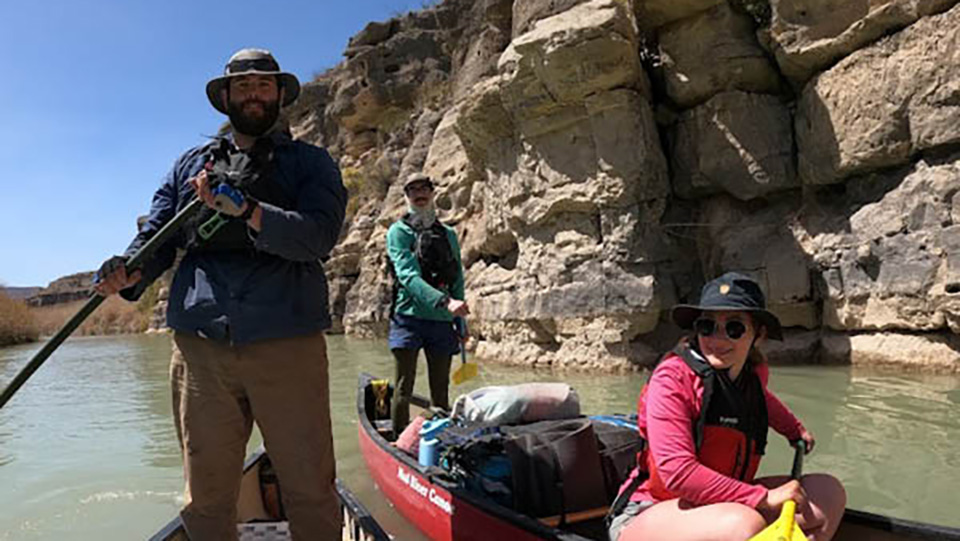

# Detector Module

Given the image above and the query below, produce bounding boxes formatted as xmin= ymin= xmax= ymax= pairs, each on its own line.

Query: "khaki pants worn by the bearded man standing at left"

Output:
xmin=170 ymin=332 xmax=341 ymax=541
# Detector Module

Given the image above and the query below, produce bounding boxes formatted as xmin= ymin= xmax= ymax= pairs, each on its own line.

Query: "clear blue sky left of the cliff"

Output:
xmin=0 ymin=0 xmax=424 ymax=286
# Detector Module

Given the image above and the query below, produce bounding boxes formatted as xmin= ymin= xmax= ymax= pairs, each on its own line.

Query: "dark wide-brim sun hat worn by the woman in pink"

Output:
xmin=671 ymin=272 xmax=783 ymax=340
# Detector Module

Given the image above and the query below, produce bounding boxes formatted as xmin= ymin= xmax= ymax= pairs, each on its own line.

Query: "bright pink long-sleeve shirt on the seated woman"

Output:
xmin=621 ymin=355 xmax=804 ymax=507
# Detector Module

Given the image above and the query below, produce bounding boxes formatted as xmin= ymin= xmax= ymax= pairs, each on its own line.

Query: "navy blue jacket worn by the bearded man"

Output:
xmin=120 ymin=134 xmax=347 ymax=344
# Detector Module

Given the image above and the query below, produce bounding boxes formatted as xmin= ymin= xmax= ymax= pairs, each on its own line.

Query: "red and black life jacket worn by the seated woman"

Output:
xmin=631 ymin=347 xmax=768 ymax=501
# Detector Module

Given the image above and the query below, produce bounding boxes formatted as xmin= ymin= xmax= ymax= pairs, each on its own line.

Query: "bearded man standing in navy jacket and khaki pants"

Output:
xmin=97 ymin=49 xmax=347 ymax=541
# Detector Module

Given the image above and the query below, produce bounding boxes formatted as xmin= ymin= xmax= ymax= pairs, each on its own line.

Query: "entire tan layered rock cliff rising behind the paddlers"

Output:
xmin=246 ymin=0 xmax=960 ymax=371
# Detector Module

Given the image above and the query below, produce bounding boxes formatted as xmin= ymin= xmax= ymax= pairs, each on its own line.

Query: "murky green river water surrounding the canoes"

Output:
xmin=0 ymin=335 xmax=960 ymax=541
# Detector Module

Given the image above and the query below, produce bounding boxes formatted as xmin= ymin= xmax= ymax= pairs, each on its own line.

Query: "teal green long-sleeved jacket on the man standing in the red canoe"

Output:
xmin=387 ymin=220 xmax=464 ymax=321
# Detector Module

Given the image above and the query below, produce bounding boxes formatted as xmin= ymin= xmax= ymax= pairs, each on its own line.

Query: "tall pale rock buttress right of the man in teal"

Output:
xmin=457 ymin=0 xmax=669 ymax=366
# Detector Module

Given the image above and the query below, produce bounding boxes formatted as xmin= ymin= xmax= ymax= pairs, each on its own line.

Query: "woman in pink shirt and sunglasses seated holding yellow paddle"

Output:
xmin=610 ymin=273 xmax=846 ymax=541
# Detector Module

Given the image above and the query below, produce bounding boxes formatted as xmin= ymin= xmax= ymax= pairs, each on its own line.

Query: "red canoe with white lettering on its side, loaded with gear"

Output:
xmin=357 ymin=374 xmax=960 ymax=541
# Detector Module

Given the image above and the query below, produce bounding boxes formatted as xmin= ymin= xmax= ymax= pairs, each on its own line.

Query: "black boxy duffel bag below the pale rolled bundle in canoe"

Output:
xmin=501 ymin=417 xmax=609 ymax=521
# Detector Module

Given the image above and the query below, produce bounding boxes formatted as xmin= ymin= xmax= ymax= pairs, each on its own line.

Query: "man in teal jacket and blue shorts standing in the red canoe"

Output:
xmin=387 ymin=173 xmax=470 ymax=434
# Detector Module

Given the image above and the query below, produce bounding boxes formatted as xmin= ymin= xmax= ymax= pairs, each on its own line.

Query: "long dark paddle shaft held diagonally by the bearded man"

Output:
xmin=0 ymin=199 xmax=203 ymax=408
